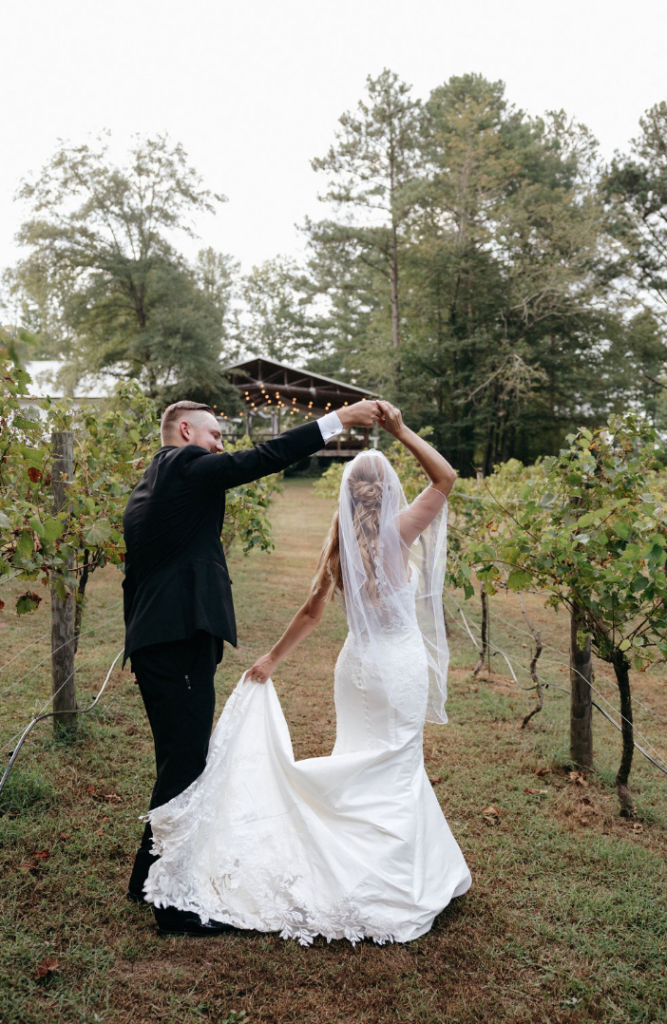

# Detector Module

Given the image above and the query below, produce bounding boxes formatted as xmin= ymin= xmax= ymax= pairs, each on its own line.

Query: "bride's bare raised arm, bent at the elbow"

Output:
xmin=377 ymin=401 xmax=456 ymax=547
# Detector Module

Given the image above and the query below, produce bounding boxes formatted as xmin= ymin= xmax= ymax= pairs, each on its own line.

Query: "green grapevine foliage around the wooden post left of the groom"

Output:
xmin=0 ymin=364 xmax=157 ymax=625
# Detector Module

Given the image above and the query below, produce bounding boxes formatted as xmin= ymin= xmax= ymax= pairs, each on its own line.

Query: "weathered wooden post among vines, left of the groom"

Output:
xmin=51 ymin=430 xmax=77 ymax=732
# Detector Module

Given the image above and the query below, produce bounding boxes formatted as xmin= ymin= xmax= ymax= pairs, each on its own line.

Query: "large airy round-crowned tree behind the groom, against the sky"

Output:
xmin=12 ymin=136 xmax=239 ymax=403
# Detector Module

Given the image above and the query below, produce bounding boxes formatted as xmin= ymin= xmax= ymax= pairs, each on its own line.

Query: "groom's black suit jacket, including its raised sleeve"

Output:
xmin=123 ymin=421 xmax=323 ymax=660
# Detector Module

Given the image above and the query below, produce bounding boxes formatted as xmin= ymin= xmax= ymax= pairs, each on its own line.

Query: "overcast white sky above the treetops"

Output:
xmin=0 ymin=0 xmax=667 ymax=284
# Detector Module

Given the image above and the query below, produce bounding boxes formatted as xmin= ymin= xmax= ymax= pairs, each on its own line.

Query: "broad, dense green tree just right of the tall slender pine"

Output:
xmin=401 ymin=75 xmax=612 ymax=475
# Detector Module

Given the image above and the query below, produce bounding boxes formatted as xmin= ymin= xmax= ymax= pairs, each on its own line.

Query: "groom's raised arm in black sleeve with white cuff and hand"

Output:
xmin=187 ymin=401 xmax=381 ymax=490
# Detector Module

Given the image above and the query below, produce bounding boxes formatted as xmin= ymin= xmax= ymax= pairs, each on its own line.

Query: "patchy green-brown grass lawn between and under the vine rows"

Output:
xmin=0 ymin=480 xmax=667 ymax=1024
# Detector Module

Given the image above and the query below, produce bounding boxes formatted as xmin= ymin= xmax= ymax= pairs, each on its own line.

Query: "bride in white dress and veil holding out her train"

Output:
xmin=144 ymin=402 xmax=471 ymax=944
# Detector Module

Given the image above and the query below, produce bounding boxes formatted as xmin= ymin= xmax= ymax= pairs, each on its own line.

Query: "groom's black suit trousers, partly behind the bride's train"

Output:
xmin=130 ymin=630 xmax=219 ymax=892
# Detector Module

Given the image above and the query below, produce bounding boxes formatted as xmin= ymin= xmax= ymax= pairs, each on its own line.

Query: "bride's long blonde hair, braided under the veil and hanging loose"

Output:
xmin=311 ymin=458 xmax=384 ymax=604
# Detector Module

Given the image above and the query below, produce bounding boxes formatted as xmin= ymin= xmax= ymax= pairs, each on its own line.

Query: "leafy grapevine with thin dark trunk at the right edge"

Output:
xmin=468 ymin=414 xmax=667 ymax=815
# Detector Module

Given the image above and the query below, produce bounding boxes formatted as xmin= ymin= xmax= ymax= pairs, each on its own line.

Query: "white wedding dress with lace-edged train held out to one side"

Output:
xmin=144 ymin=452 xmax=471 ymax=944
